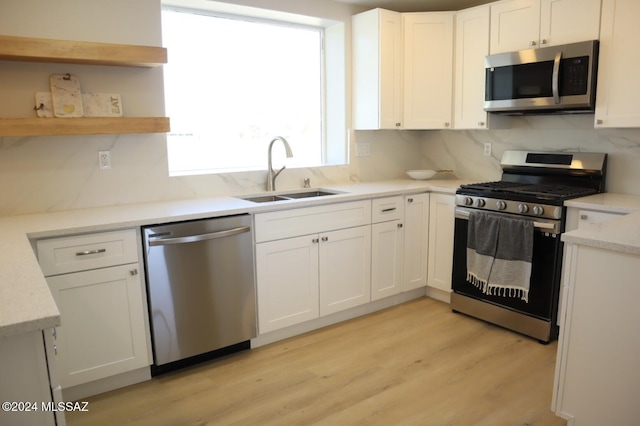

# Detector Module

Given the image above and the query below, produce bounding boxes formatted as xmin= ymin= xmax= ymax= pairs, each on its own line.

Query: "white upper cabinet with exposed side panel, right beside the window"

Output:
xmin=352 ymin=9 xmax=402 ymax=130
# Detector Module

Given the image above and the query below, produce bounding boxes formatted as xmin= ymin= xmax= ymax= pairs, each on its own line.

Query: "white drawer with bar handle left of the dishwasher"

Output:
xmin=36 ymin=229 xmax=138 ymax=276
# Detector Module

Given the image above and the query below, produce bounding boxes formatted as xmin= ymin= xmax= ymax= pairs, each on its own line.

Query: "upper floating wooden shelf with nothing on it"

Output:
xmin=0 ymin=35 xmax=167 ymax=67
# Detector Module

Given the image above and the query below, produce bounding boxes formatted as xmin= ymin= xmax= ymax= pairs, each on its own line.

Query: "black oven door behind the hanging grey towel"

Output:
xmin=452 ymin=207 xmax=562 ymax=324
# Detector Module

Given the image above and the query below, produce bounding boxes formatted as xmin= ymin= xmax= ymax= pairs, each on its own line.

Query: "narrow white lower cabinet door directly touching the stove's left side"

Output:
xmin=427 ymin=194 xmax=455 ymax=293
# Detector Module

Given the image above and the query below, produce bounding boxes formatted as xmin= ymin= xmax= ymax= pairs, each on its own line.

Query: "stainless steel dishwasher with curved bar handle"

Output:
xmin=142 ymin=215 xmax=257 ymax=375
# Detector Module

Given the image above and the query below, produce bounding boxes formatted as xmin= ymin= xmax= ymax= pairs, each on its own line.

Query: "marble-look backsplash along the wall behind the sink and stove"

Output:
xmin=0 ymin=115 xmax=640 ymax=216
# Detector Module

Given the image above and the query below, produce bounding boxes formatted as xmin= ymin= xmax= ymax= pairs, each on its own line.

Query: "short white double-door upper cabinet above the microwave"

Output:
xmin=490 ymin=0 xmax=601 ymax=54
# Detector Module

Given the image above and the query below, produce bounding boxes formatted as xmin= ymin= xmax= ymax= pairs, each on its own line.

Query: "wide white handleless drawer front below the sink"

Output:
xmin=255 ymin=200 xmax=371 ymax=243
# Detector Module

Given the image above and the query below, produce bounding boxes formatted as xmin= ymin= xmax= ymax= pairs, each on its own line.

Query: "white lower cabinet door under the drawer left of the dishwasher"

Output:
xmin=47 ymin=264 xmax=149 ymax=388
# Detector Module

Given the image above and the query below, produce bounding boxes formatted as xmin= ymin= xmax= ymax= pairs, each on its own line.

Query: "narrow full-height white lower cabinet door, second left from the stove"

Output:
xmin=402 ymin=193 xmax=429 ymax=291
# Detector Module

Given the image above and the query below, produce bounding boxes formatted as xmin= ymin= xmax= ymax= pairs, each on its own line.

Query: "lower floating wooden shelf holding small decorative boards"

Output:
xmin=0 ymin=117 xmax=170 ymax=136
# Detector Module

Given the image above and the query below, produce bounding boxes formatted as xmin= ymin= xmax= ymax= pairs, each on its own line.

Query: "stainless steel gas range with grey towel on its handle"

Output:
xmin=451 ymin=151 xmax=607 ymax=343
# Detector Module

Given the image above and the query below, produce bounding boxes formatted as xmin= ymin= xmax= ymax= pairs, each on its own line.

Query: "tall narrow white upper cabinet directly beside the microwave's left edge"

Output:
xmin=453 ymin=6 xmax=491 ymax=129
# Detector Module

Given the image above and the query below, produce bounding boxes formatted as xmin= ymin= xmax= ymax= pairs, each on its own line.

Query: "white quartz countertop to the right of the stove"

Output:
xmin=562 ymin=193 xmax=640 ymax=255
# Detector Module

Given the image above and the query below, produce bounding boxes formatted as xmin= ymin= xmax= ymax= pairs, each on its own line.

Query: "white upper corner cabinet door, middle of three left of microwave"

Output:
xmin=402 ymin=12 xmax=455 ymax=129
